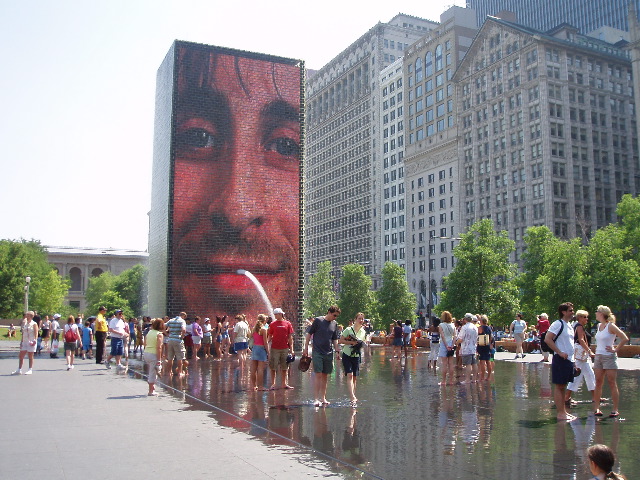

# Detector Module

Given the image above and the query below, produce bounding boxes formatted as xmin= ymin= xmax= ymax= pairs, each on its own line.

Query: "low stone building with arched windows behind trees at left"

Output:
xmin=45 ymin=247 xmax=149 ymax=313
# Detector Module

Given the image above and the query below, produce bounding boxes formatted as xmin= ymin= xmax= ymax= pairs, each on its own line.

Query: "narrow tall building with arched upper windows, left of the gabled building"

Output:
xmin=402 ymin=6 xmax=478 ymax=323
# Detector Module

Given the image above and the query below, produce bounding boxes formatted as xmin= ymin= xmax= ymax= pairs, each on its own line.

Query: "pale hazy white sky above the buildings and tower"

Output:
xmin=0 ymin=0 xmax=464 ymax=250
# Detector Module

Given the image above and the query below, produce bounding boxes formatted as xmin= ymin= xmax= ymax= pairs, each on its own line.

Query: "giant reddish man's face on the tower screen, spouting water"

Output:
xmin=168 ymin=45 xmax=302 ymax=319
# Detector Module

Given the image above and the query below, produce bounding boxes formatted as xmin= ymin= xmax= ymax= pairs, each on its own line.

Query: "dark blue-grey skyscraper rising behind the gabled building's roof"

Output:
xmin=467 ymin=0 xmax=640 ymax=33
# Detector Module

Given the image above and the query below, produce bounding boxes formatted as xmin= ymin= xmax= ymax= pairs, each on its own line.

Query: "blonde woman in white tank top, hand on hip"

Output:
xmin=593 ymin=305 xmax=629 ymax=418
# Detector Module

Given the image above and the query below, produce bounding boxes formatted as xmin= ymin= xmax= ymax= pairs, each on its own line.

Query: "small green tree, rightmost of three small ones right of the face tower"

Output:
xmin=374 ymin=262 xmax=416 ymax=328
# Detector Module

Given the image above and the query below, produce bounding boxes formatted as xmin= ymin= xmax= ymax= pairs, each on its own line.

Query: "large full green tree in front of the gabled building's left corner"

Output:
xmin=436 ymin=219 xmax=519 ymax=324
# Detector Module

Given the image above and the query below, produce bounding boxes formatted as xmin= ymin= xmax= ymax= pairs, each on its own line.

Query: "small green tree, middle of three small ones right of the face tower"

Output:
xmin=338 ymin=263 xmax=373 ymax=325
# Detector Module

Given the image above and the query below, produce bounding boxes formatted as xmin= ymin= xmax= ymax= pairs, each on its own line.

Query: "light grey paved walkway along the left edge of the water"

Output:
xmin=0 ymin=348 xmax=342 ymax=480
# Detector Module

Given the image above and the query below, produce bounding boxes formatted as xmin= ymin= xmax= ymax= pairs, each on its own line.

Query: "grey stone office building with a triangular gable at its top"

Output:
xmin=454 ymin=18 xmax=640 ymax=261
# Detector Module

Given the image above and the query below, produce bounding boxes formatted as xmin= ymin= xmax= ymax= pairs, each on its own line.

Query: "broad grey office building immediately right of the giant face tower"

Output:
xmin=304 ymin=14 xmax=437 ymax=288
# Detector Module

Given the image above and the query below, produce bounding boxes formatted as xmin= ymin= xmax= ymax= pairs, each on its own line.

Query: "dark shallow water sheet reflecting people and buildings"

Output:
xmin=139 ymin=347 xmax=640 ymax=480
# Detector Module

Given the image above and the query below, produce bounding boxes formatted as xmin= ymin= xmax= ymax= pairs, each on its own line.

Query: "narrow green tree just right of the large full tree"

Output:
xmin=518 ymin=226 xmax=560 ymax=318
